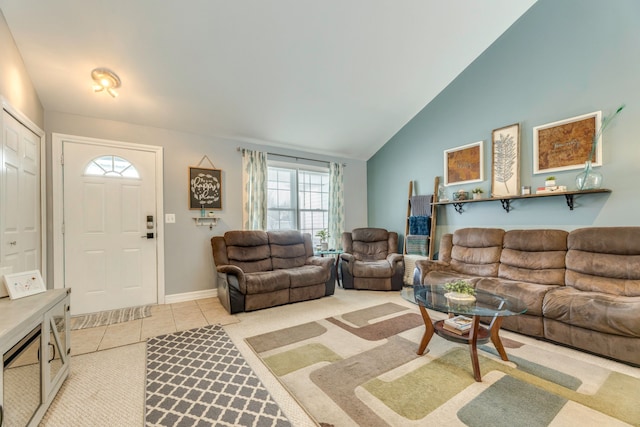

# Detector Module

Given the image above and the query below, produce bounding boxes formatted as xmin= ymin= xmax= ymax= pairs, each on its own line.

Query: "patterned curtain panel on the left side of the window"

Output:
xmin=240 ymin=148 xmax=267 ymax=230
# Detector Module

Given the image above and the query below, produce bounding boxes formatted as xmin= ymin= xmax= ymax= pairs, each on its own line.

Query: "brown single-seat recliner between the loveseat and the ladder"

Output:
xmin=340 ymin=228 xmax=404 ymax=291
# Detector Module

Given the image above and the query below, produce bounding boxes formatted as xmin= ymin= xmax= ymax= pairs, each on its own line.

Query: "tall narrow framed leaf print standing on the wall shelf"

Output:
xmin=491 ymin=123 xmax=520 ymax=197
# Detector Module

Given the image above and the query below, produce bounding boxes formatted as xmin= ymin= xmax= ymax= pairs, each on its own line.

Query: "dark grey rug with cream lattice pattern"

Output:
xmin=145 ymin=325 xmax=291 ymax=427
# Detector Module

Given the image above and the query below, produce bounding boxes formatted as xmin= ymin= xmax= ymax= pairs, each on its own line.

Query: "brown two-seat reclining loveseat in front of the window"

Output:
xmin=211 ymin=230 xmax=336 ymax=314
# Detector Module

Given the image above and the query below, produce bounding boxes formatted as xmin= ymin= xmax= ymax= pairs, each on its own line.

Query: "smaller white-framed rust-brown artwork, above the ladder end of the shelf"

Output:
xmin=444 ymin=141 xmax=484 ymax=185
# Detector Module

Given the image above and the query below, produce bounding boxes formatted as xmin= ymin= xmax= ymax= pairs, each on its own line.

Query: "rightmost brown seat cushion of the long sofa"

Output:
xmin=542 ymin=286 xmax=640 ymax=337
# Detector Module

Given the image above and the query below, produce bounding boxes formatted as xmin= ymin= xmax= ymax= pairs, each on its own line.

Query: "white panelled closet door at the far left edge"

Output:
xmin=0 ymin=110 xmax=42 ymax=273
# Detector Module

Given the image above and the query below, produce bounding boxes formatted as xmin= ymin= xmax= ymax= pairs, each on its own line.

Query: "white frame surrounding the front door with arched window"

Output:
xmin=51 ymin=133 xmax=164 ymax=304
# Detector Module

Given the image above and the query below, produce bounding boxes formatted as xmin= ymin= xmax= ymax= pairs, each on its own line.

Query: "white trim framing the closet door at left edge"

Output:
xmin=0 ymin=96 xmax=48 ymax=283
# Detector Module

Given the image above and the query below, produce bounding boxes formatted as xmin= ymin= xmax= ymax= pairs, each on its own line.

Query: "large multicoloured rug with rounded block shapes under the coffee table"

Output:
xmin=246 ymin=302 xmax=640 ymax=427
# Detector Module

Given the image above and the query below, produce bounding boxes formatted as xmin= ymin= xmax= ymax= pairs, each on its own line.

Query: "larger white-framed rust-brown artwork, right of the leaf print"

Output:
xmin=533 ymin=111 xmax=602 ymax=174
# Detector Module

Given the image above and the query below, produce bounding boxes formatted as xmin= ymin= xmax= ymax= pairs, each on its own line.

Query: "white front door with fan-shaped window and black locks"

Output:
xmin=62 ymin=140 xmax=158 ymax=315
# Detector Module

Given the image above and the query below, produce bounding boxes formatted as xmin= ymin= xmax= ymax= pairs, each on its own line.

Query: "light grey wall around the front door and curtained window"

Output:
xmin=44 ymin=111 xmax=367 ymax=295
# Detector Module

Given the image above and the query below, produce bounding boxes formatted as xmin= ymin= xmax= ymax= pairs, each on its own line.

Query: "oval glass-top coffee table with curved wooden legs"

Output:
xmin=410 ymin=285 xmax=527 ymax=381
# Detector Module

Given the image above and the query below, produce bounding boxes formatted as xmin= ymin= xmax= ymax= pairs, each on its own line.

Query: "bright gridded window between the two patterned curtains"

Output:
xmin=267 ymin=165 xmax=329 ymax=243
